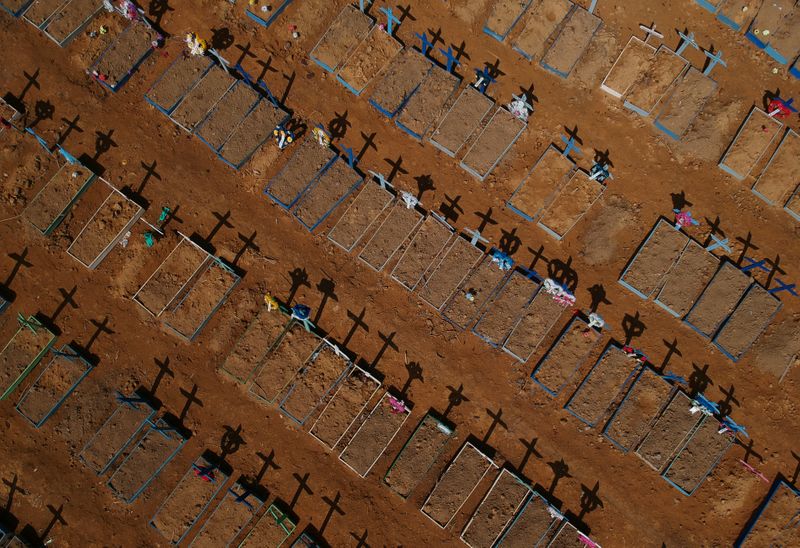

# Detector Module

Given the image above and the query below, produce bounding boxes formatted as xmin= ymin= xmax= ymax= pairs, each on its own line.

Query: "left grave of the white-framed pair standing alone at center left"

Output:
xmin=132 ymin=236 xmax=213 ymax=318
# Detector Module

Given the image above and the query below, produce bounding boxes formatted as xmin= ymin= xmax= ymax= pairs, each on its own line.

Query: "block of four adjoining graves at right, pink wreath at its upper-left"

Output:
xmin=619 ymin=218 xmax=796 ymax=362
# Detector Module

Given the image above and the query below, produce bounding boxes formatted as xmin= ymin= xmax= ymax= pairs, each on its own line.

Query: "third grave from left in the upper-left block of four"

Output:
xmin=195 ymin=80 xmax=260 ymax=152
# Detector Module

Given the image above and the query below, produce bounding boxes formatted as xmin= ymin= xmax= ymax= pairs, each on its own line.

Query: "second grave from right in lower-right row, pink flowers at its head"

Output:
xmin=636 ymin=391 xmax=700 ymax=472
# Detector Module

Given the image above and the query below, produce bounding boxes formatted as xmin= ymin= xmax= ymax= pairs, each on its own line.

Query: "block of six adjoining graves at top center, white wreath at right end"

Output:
xmin=309 ymin=5 xmax=533 ymax=181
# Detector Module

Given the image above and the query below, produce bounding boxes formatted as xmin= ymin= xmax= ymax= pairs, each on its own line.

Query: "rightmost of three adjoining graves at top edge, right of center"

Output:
xmin=541 ymin=5 xmax=603 ymax=78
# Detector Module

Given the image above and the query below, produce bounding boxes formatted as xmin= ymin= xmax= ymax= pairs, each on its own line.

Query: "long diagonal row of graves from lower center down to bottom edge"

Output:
xmin=220 ymin=297 xmax=596 ymax=548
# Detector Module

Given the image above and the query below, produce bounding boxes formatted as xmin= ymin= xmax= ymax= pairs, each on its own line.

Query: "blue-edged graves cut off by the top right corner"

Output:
xmin=695 ymin=0 xmax=800 ymax=78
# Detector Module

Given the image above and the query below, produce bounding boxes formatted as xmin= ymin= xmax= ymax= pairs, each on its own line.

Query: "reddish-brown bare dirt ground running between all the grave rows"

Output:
xmin=0 ymin=0 xmax=800 ymax=546
